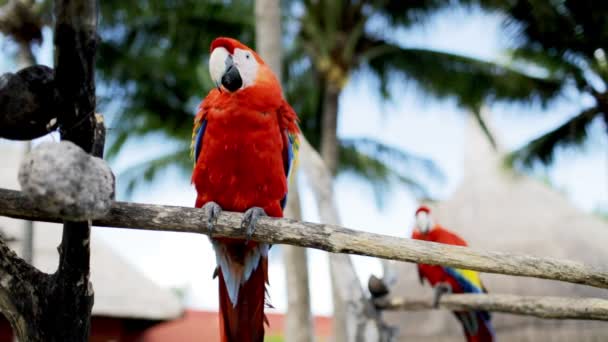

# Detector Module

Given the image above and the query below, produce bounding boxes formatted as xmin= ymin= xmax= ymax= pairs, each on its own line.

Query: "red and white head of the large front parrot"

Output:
xmin=209 ymin=37 xmax=280 ymax=93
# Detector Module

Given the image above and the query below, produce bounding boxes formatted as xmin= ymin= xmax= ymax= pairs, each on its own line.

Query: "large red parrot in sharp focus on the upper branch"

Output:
xmin=191 ymin=37 xmax=299 ymax=342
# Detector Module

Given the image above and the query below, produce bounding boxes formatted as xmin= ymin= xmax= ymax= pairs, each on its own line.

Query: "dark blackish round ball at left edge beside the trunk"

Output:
xmin=0 ymin=65 xmax=57 ymax=140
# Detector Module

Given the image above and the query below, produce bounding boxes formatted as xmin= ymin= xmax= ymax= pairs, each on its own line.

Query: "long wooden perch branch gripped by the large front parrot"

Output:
xmin=0 ymin=189 xmax=608 ymax=288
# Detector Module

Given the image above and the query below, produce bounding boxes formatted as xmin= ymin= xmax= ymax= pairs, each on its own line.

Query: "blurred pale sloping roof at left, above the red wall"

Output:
xmin=0 ymin=143 xmax=183 ymax=320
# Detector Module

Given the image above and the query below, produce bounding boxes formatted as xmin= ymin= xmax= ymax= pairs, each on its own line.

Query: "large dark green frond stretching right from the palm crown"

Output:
xmin=364 ymin=39 xmax=564 ymax=108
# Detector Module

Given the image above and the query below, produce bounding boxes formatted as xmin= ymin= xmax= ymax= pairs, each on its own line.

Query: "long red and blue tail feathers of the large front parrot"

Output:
xmin=216 ymin=242 xmax=268 ymax=342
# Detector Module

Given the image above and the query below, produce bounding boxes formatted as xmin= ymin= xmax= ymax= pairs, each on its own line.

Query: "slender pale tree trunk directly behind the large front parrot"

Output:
xmin=255 ymin=0 xmax=313 ymax=342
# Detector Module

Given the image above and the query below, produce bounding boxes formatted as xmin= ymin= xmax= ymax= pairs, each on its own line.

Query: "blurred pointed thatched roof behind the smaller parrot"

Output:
xmin=388 ymin=115 xmax=608 ymax=341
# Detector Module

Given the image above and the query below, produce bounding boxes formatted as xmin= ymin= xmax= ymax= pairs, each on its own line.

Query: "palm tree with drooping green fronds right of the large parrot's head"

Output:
xmin=286 ymin=0 xmax=562 ymax=341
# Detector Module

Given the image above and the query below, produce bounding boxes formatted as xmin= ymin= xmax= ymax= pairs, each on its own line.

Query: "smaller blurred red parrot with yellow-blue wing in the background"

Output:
xmin=412 ymin=206 xmax=494 ymax=342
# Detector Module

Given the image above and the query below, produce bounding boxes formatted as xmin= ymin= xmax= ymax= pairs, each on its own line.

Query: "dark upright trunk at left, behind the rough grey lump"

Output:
xmin=43 ymin=0 xmax=98 ymax=341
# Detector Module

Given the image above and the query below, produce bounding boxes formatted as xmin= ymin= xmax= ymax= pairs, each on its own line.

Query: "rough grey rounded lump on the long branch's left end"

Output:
xmin=19 ymin=141 xmax=114 ymax=221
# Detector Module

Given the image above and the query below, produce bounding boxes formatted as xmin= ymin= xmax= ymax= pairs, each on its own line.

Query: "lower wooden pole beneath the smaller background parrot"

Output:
xmin=375 ymin=294 xmax=608 ymax=321
